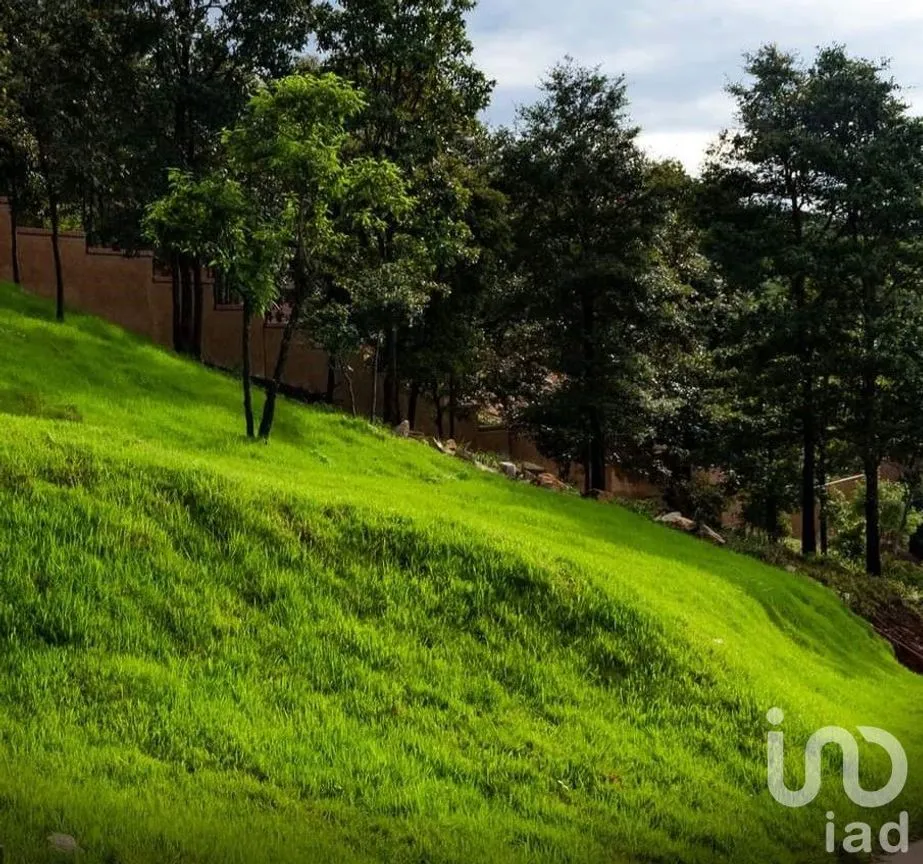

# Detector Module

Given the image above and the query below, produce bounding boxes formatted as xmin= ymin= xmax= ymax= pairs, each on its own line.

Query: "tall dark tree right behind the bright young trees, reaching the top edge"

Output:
xmin=317 ymin=0 xmax=492 ymax=424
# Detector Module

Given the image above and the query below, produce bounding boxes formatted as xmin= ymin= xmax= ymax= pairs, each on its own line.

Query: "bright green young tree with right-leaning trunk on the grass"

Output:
xmin=219 ymin=73 xmax=413 ymax=438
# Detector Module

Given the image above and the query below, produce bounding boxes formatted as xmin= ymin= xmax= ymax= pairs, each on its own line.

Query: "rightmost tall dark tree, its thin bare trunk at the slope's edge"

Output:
xmin=809 ymin=47 xmax=923 ymax=575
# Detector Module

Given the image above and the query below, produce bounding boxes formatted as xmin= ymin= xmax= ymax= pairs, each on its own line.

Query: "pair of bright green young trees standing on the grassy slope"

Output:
xmin=145 ymin=72 xmax=420 ymax=438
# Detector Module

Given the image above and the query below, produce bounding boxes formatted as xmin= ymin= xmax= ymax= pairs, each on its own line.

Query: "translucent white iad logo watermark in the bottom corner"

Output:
xmin=766 ymin=708 xmax=910 ymax=854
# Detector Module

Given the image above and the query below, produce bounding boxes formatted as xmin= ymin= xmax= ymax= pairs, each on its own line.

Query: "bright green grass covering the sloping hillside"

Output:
xmin=0 ymin=278 xmax=923 ymax=864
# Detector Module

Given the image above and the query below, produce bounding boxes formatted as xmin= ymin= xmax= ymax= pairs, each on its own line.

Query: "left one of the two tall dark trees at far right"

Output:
xmin=707 ymin=46 xmax=830 ymax=555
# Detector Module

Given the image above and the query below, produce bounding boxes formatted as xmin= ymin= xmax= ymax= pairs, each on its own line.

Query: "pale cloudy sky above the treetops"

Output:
xmin=470 ymin=0 xmax=923 ymax=172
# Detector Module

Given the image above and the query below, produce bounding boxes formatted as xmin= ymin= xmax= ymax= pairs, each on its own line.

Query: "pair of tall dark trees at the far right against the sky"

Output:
xmin=703 ymin=46 xmax=923 ymax=574
